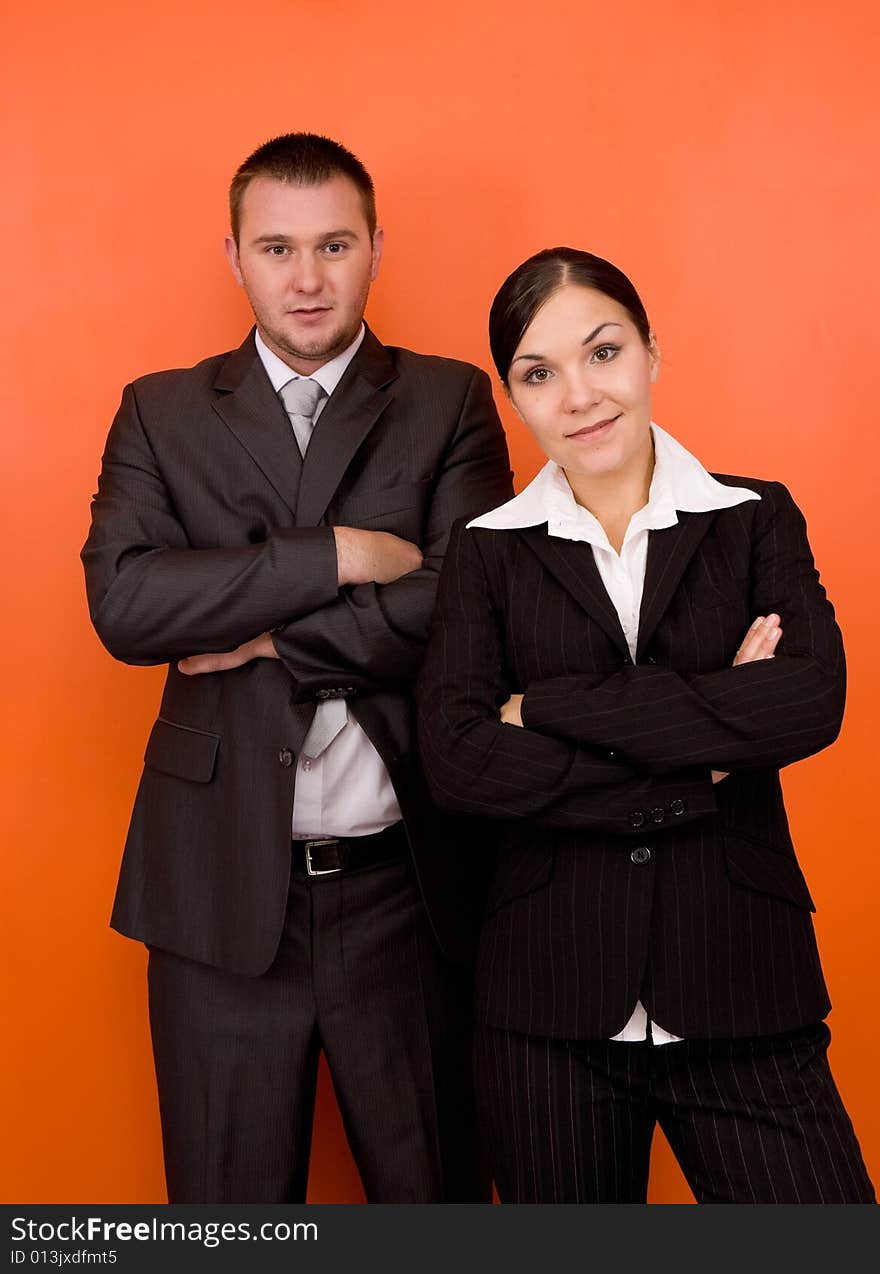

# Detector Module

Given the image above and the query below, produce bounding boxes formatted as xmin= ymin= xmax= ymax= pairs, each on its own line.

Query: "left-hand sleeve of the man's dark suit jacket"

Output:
xmin=82 ymin=385 xmax=337 ymax=664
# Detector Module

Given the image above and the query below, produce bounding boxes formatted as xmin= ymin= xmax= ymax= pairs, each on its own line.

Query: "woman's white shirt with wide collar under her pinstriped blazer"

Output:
xmin=467 ymin=424 xmax=760 ymax=1043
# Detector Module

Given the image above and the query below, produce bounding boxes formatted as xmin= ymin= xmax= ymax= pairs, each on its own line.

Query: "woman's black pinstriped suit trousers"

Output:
xmin=475 ymin=1022 xmax=875 ymax=1204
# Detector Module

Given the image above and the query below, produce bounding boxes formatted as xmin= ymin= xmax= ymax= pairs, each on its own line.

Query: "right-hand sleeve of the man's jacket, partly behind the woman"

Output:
xmin=273 ymin=368 xmax=513 ymax=701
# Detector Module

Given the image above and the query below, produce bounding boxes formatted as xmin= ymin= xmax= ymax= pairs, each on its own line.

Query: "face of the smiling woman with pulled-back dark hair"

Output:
xmin=508 ymin=284 xmax=660 ymax=480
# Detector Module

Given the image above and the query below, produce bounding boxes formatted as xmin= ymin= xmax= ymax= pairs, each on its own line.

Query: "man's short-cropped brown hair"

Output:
xmin=229 ymin=132 xmax=376 ymax=243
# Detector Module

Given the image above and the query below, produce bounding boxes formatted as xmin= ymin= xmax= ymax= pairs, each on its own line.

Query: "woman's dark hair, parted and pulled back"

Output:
xmin=489 ymin=247 xmax=651 ymax=385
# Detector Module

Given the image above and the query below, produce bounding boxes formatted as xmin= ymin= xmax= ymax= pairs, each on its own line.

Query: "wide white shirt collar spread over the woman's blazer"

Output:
xmin=467 ymin=423 xmax=760 ymax=547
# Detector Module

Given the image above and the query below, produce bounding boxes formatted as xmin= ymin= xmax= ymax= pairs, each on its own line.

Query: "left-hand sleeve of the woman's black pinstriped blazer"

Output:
xmin=416 ymin=522 xmax=717 ymax=834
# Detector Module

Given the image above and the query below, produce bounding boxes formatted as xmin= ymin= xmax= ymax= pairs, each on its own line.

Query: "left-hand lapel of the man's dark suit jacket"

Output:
xmin=214 ymin=330 xmax=302 ymax=513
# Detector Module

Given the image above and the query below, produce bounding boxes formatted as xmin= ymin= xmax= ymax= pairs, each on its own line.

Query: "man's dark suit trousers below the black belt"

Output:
xmin=148 ymin=861 xmax=490 ymax=1203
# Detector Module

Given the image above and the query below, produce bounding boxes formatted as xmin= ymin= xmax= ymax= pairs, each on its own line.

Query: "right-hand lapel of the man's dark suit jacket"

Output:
xmin=297 ymin=329 xmax=397 ymax=526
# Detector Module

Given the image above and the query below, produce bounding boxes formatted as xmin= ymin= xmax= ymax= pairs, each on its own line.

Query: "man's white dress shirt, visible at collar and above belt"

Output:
xmin=255 ymin=324 xmax=401 ymax=841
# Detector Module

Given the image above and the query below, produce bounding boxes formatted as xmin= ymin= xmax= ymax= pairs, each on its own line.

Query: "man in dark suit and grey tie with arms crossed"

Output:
xmin=83 ymin=134 xmax=511 ymax=1203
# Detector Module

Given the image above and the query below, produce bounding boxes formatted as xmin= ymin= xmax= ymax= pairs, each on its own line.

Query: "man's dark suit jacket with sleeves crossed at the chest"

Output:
xmin=83 ymin=331 xmax=512 ymax=975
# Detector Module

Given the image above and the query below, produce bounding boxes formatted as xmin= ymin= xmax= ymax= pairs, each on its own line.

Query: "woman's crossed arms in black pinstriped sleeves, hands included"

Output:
xmin=418 ymin=485 xmax=844 ymax=832
